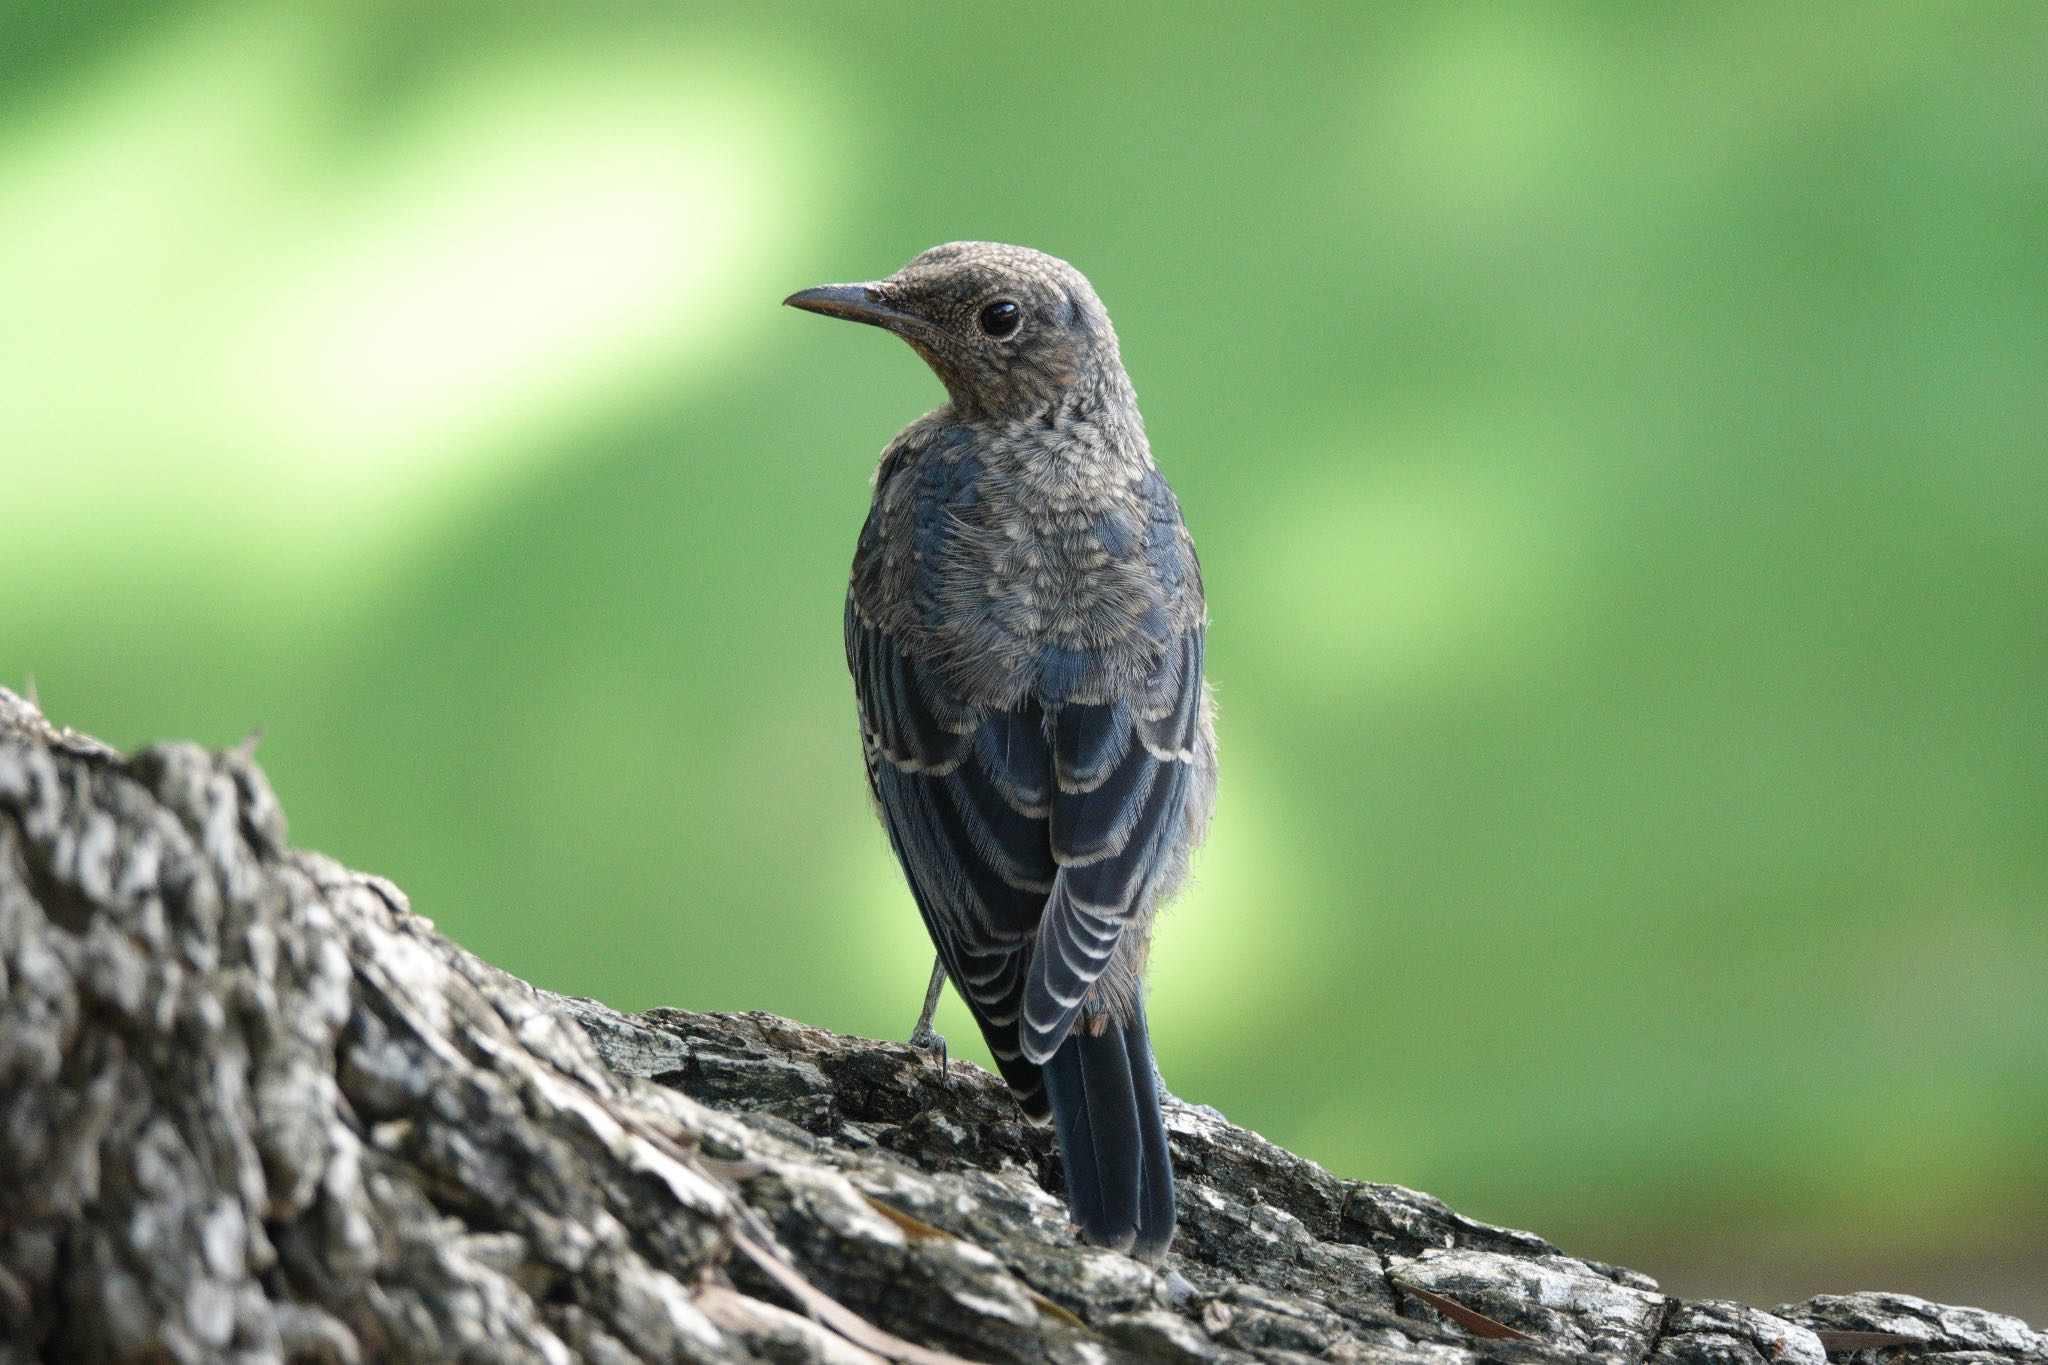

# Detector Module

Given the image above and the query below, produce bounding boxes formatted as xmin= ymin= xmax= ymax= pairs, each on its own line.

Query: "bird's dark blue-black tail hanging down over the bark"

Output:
xmin=1044 ymin=1003 xmax=1174 ymax=1261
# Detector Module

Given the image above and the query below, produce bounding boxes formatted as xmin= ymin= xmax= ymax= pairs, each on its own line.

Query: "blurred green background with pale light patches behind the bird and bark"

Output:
xmin=0 ymin=0 xmax=2048 ymax=1318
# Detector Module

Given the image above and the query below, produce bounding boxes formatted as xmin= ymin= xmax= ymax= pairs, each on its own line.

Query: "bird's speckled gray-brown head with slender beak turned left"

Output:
xmin=782 ymin=241 xmax=1130 ymax=417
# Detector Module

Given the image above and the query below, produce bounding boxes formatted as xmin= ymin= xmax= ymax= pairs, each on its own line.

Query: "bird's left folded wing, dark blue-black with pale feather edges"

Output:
xmin=846 ymin=596 xmax=1057 ymax=1119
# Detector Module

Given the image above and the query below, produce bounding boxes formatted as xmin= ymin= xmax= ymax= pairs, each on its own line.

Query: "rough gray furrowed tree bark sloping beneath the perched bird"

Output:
xmin=0 ymin=690 xmax=2048 ymax=1365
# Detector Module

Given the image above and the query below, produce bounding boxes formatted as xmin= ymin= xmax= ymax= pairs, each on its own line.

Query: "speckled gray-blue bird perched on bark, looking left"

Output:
xmin=784 ymin=241 xmax=1217 ymax=1263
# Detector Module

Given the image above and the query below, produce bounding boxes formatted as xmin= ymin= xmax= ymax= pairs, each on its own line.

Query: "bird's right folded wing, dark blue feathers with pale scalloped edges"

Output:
xmin=1018 ymin=626 xmax=1204 ymax=1064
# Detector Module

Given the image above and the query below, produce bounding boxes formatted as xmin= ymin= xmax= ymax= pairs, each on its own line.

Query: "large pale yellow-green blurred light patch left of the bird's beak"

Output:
xmin=0 ymin=6 xmax=803 ymax=596
